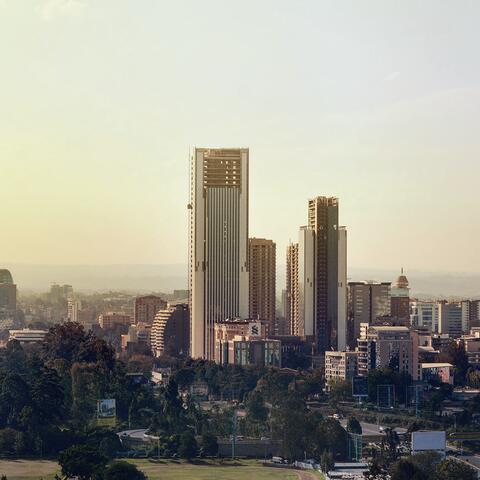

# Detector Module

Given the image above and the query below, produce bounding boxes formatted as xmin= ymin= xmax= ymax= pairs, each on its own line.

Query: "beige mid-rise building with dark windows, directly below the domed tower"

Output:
xmin=358 ymin=324 xmax=419 ymax=380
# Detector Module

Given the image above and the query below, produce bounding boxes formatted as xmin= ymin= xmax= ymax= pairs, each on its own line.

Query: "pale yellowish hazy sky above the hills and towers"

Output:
xmin=0 ymin=0 xmax=480 ymax=272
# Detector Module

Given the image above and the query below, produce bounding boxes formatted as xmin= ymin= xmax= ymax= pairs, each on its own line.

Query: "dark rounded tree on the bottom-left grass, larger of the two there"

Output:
xmin=58 ymin=445 xmax=107 ymax=480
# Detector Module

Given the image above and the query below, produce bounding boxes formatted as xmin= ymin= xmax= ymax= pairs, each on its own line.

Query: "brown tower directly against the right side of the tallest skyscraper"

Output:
xmin=248 ymin=238 xmax=276 ymax=334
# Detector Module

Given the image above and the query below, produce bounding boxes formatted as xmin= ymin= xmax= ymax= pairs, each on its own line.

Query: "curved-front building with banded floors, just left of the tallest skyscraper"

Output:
xmin=150 ymin=303 xmax=190 ymax=357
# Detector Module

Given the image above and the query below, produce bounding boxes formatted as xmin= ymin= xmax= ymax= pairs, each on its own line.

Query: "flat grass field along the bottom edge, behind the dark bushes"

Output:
xmin=0 ymin=460 xmax=322 ymax=480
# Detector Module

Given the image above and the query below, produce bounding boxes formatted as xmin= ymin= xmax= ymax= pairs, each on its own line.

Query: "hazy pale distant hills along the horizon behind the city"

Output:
xmin=0 ymin=263 xmax=480 ymax=298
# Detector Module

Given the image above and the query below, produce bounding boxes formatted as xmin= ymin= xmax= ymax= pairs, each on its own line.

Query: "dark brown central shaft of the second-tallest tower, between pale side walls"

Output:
xmin=308 ymin=197 xmax=339 ymax=354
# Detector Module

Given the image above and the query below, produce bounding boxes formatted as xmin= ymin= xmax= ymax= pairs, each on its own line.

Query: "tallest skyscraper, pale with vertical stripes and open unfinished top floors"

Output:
xmin=189 ymin=148 xmax=249 ymax=359
